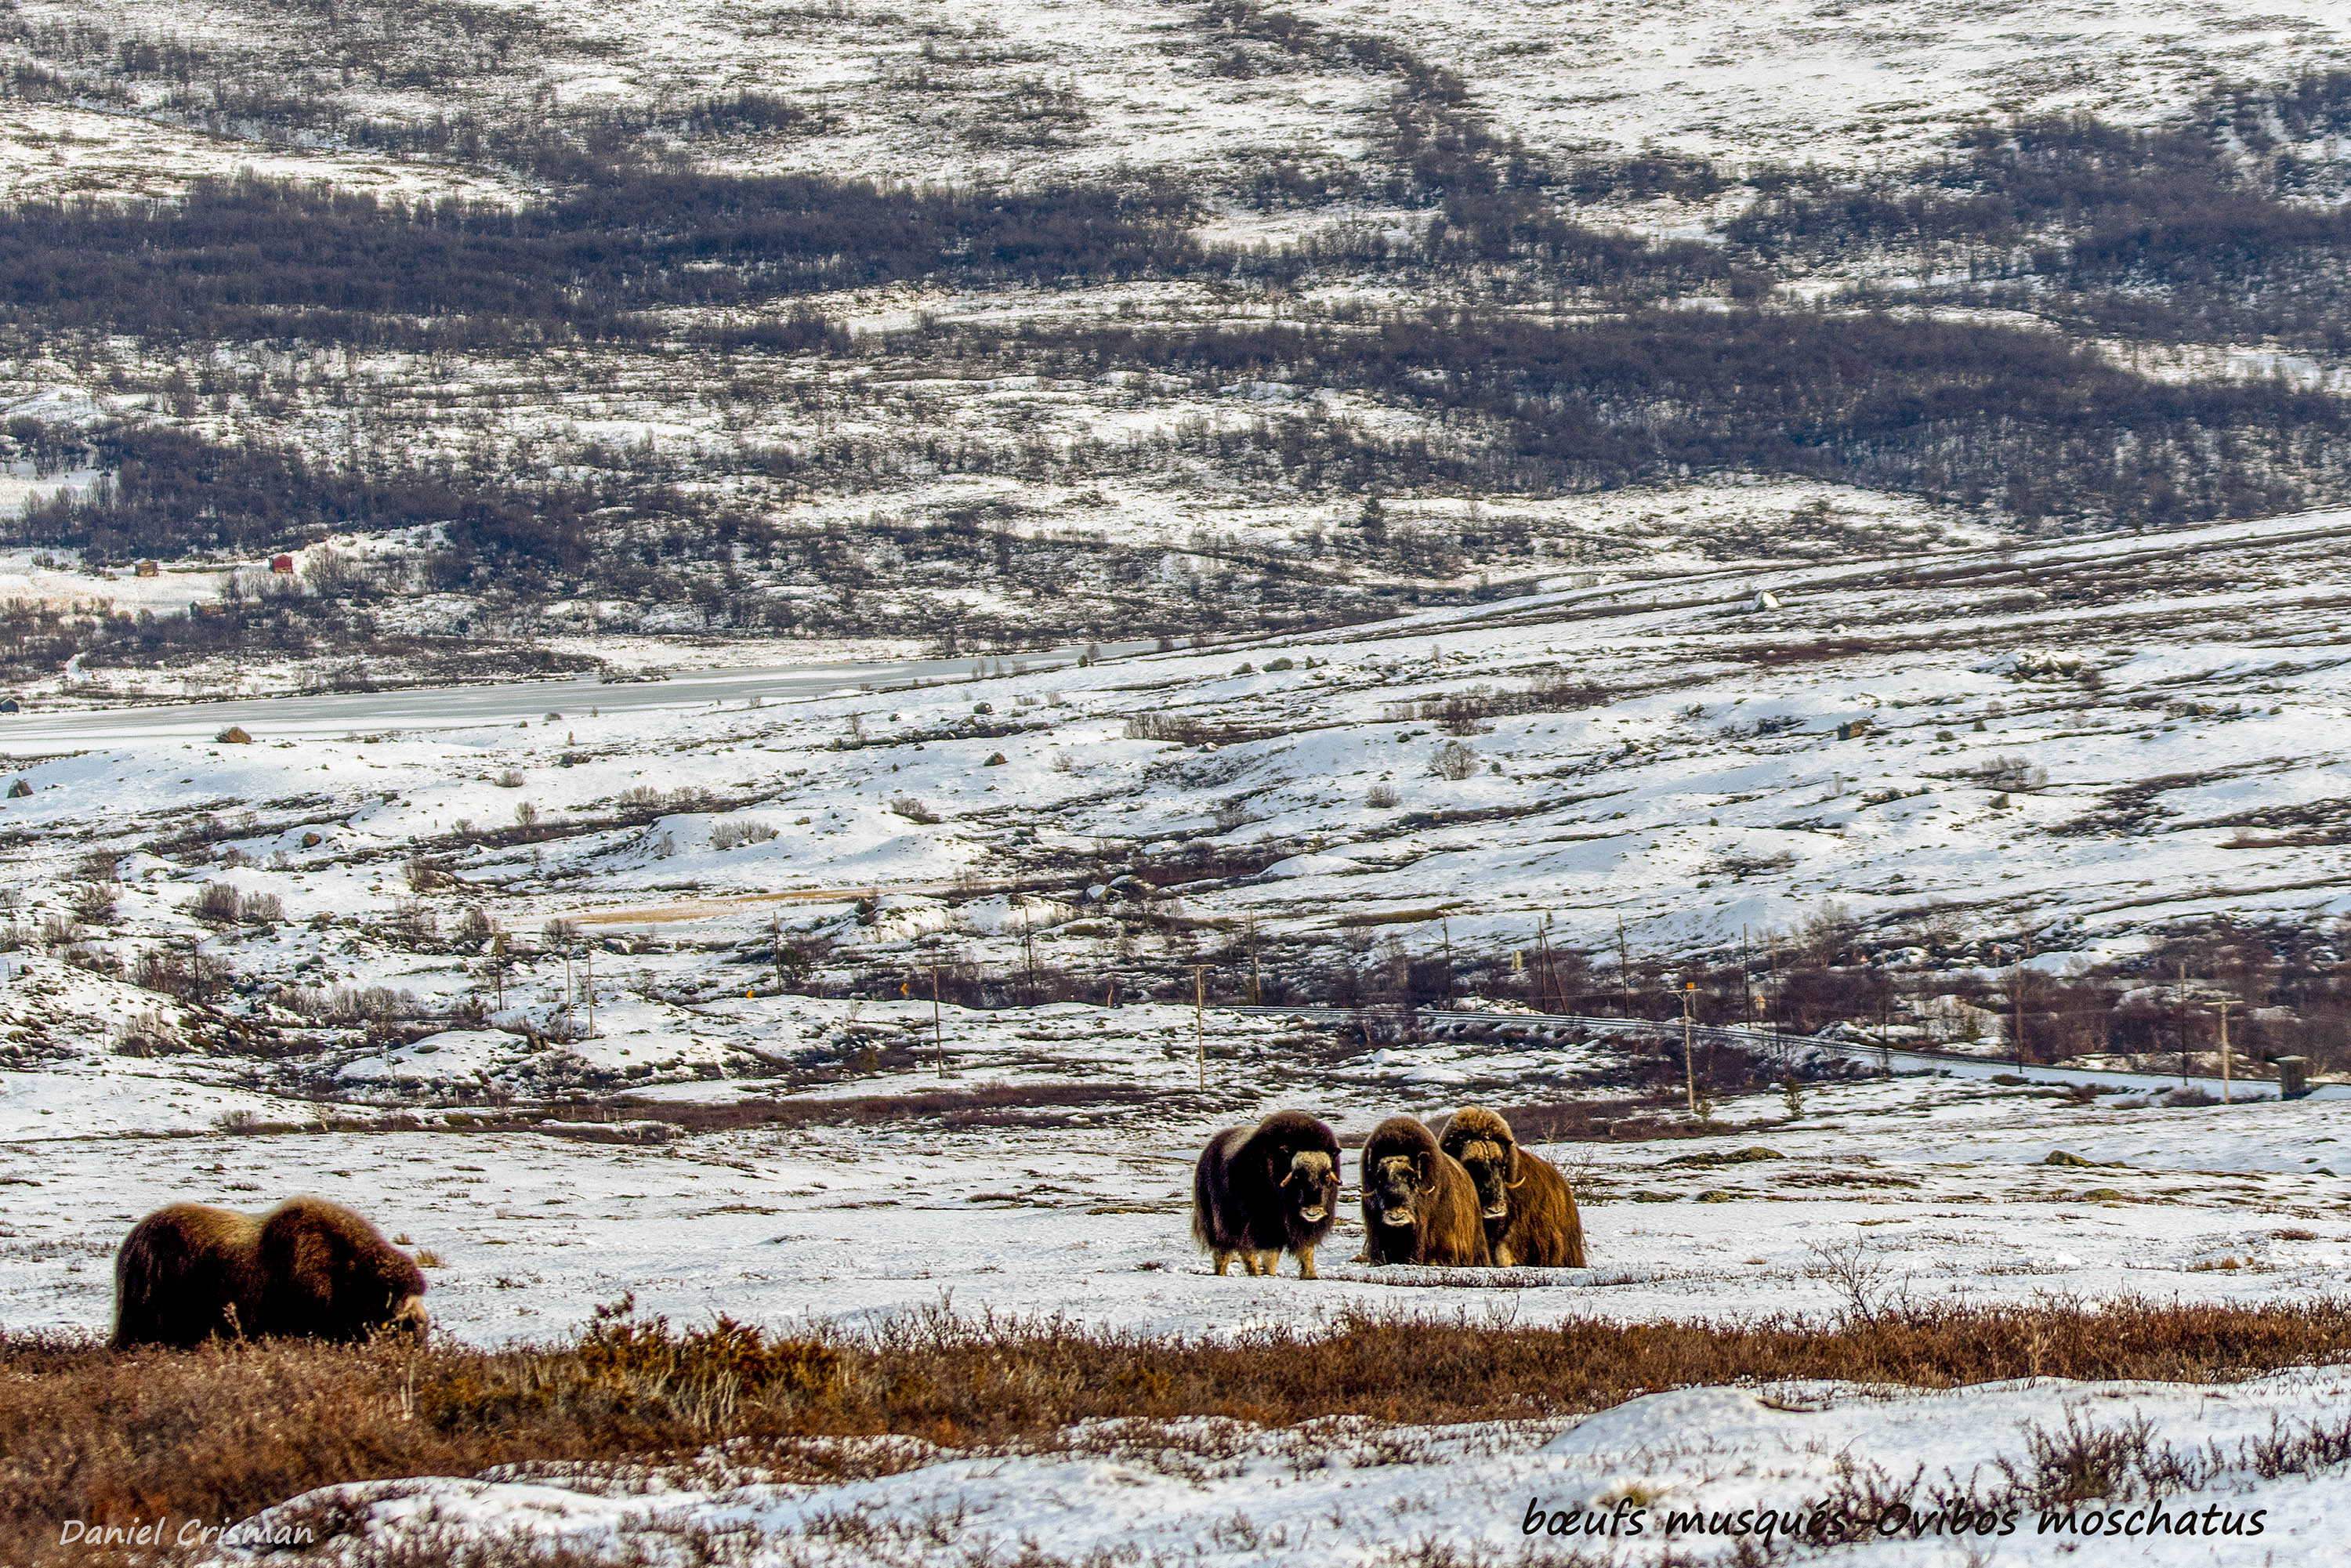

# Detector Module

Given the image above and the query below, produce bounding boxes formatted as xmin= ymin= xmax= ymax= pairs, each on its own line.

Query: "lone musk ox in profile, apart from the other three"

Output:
xmin=113 ymin=1199 xmax=426 ymax=1349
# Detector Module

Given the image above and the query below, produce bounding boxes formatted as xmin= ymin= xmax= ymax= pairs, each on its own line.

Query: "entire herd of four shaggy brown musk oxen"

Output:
xmin=113 ymin=1105 xmax=1585 ymax=1349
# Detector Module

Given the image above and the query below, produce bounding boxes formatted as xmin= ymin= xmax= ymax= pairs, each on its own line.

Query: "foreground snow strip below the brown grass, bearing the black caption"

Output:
xmin=221 ymin=1371 xmax=2351 ymax=1568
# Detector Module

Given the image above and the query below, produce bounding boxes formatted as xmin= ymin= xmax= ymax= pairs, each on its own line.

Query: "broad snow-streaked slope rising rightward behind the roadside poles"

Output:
xmin=0 ymin=512 xmax=2351 ymax=969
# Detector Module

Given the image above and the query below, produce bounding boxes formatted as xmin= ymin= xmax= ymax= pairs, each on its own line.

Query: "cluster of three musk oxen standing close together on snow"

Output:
xmin=1192 ymin=1105 xmax=1585 ymax=1279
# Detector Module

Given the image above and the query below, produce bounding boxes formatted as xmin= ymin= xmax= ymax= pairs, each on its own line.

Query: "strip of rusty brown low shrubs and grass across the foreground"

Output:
xmin=13 ymin=1300 xmax=2351 ymax=1568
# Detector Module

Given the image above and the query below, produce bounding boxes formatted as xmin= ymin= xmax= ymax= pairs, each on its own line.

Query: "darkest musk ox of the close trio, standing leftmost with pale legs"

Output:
xmin=1192 ymin=1110 xmax=1338 ymax=1279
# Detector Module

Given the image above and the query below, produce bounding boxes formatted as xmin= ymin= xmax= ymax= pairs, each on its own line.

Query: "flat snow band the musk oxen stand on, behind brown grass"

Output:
xmin=13 ymin=1067 xmax=2351 ymax=1345
